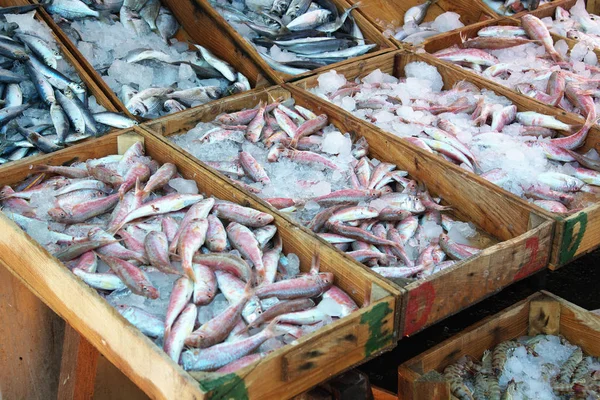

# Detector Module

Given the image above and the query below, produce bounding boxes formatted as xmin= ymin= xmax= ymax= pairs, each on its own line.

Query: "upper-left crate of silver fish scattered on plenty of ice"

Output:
xmin=34 ymin=0 xmax=274 ymax=120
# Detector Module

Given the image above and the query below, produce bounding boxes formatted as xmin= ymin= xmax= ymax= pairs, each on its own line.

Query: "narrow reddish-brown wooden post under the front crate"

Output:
xmin=56 ymin=324 xmax=98 ymax=400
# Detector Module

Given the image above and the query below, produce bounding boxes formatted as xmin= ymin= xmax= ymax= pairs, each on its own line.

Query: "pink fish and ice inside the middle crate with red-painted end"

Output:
xmin=169 ymin=95 xmax=492 ymax=278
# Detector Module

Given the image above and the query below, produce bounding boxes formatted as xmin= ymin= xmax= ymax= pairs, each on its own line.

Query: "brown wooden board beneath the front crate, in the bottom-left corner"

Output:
xmin=0 ymin=262 xmax=65 ymax=400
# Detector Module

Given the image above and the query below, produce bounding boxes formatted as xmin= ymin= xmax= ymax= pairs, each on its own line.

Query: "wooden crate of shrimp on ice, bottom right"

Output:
xmin=398 ymin=291 xmax=600 ymax=400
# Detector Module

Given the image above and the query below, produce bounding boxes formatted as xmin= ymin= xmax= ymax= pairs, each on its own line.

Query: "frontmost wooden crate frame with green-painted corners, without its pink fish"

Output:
xmin=0 ymin=127 xmax=398 ymax=399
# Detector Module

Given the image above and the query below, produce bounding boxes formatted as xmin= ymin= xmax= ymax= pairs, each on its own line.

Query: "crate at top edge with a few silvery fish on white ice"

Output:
xmin=350 ymin=0 xmax=496 ymax=47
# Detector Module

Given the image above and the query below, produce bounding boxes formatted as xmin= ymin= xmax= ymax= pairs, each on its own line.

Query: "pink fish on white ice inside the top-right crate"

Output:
xmin=433 ymin=15 xmax=600 ymax=124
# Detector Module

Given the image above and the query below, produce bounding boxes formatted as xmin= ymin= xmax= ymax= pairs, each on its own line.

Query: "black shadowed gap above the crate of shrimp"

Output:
xmin=359 ymin=250 xmax=600 ymax=393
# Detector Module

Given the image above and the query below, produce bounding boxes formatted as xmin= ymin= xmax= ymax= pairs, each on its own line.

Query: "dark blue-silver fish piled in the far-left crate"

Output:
xmin=0 ymin=6 xmax=135 ymax=164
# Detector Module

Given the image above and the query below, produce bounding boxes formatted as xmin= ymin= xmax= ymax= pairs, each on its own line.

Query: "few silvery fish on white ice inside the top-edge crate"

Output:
xmin=392 ymin=0 xmax=465 ymax=45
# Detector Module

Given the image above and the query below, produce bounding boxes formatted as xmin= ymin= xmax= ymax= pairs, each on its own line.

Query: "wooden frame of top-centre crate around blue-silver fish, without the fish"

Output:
xmin=188 ymin=0 xmax=396 ymax=83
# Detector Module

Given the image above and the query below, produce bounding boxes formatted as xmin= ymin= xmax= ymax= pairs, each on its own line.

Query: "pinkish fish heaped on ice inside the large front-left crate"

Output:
xmin=0 ymin=150 xmax=366 ymax=369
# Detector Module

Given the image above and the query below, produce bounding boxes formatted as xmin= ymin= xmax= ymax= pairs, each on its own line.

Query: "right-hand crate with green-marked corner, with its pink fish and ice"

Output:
xmin=298 ymin=46 xmax=600 ymax=268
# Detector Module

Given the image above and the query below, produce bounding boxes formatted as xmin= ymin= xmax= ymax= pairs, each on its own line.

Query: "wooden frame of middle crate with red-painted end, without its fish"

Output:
xmin=142 ymin=83 xmax=552 ymax=336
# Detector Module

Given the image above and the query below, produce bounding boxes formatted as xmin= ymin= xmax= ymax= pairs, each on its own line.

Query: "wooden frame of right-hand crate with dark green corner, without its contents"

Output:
xmin=294 ymin=48 xmax=600 ymax=269
